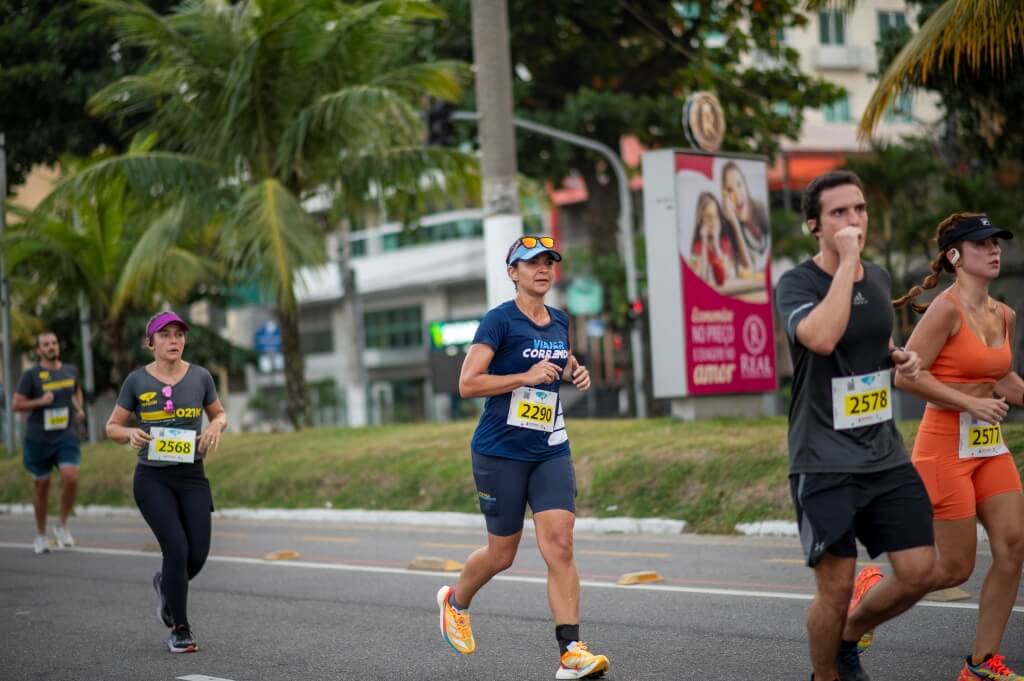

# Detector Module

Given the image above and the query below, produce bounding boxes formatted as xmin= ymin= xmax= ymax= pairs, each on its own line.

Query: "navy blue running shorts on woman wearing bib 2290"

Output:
xmin=473 ymin=452 xmax=577 ymax=537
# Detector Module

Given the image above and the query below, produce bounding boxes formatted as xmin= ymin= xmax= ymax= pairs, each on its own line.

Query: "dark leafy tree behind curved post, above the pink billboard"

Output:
xmin=423 ymin=0 xmax=842 ymax=318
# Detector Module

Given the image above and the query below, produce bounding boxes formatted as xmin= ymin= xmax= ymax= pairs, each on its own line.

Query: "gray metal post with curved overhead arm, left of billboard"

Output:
xmin=452 ymin=112 xmax=647 ymax=419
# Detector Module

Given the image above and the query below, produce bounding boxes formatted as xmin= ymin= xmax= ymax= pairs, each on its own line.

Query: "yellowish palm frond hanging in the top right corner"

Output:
xmin=807 ymin=0 xmax=1024 ymax=137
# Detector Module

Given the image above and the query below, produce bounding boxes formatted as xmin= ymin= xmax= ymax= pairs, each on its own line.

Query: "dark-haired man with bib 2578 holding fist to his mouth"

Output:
xmin=775 ymin=171 xmax=935 ymax=681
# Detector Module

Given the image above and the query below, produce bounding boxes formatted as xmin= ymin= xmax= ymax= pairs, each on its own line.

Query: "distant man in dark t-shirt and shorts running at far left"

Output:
xmin=11 ymin=332 xmax=85 ymax=553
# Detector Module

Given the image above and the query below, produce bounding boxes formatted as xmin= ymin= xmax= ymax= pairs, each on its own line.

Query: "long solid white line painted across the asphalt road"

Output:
xmin=0 ymin=542 xmax=1024 ymax=612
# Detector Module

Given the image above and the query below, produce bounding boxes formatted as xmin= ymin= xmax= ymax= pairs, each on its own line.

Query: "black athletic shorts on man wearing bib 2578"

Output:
xmin=790 ymin=462 xmax=935 ymax=567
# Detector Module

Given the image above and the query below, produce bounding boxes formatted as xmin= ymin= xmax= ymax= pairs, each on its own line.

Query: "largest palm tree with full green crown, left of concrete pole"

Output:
xmin=47 ymin=0 xmax=476 ymax=428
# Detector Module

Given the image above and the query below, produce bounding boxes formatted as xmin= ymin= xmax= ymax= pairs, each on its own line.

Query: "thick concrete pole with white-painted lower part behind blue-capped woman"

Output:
xmin=471 ymin=0 xmax=522 ymax=307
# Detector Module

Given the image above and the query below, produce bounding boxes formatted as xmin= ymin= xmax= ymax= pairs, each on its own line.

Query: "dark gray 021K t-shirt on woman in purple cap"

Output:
xmin=118 ymin=365 xmax=217 ymax=466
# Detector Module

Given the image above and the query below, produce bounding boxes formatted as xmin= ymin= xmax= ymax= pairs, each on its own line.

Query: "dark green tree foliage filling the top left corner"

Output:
xmin=0 ymin=0 xmax=176 ymax=186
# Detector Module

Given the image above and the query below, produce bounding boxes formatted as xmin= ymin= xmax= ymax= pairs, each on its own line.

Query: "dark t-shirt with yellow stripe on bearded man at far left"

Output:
xmin=15 ymin=363 xmax=81 ymax=442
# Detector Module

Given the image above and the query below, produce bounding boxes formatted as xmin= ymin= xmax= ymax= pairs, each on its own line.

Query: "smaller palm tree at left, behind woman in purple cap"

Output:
xmin=3 ymin=138 xmax=217 ymax=385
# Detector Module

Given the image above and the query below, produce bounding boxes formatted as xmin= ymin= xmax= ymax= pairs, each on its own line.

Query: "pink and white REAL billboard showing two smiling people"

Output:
xmin=643 ymin=150 xmax=777 ymax=397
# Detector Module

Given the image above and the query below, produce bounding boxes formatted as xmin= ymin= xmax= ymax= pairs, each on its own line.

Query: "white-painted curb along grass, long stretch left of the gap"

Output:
xmin=0 ymin=504 xmax=686 ymax=535
